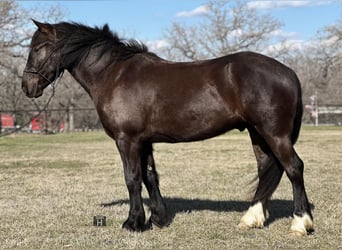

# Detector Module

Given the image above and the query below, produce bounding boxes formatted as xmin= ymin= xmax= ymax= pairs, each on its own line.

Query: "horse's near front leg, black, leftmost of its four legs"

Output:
xmin=116 ymin=138 xmax=145 ymax=232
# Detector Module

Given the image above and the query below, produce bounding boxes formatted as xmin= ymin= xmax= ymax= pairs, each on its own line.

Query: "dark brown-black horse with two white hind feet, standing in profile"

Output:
xmin=22 ymin=21 xmax=313 ymax=235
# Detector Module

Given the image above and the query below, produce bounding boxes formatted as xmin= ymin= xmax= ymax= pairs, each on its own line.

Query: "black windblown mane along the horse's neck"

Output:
xmin=54 ymin=22 xmax=152 ymax=65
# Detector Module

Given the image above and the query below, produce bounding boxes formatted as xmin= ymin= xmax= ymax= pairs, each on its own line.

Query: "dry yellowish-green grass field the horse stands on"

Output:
xmin=0 ymin=127 xmax=342 ymax=249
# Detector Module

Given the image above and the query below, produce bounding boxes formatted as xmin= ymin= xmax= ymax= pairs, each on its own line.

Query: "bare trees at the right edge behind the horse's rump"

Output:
xmin=287 ymin=16 xmax=342 ymax=122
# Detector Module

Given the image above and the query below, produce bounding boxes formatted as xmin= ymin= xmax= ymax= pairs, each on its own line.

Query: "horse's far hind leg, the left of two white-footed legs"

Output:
xmin=239 ymin=128 xmax=284 ymax=229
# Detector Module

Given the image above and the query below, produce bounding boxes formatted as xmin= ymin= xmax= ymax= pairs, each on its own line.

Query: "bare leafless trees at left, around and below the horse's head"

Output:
xmin=0 ymin=0 xmax=98 ymax=131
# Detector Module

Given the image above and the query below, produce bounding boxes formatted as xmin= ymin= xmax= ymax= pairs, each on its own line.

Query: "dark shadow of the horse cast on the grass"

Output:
xmin=101 ymin=197 xmax=293 ymax=226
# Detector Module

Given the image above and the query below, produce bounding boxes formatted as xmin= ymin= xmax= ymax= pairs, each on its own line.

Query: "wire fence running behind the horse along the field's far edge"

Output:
xmin=0 ymin=106 xmax=342 ymax=136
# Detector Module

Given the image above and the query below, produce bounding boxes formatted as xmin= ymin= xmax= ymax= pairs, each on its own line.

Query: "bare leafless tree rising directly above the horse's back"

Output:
xmin=166 ymin=0 xmax=281 ymax=60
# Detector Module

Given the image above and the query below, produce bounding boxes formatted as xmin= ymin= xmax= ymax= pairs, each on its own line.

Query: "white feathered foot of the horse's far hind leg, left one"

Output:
xmin=238 ymin=202 xmax=266 ymax=229
